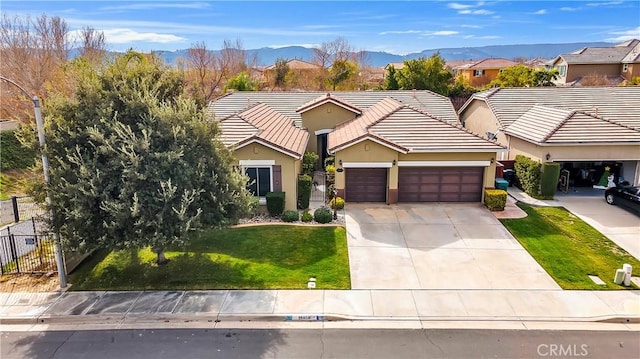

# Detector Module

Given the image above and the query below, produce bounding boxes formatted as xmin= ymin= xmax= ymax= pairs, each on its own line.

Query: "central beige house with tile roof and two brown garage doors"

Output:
xmin=208 ymin=91 xmax=504 ymax=209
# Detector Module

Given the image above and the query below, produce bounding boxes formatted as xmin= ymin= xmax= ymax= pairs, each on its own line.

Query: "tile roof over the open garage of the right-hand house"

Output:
xmin=505 ymin=105 xmax=640 ymax=144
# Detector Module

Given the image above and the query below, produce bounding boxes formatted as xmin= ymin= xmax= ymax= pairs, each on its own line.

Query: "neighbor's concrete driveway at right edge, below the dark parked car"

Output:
xmin=557 ymin=192 xmax=640 ymax=259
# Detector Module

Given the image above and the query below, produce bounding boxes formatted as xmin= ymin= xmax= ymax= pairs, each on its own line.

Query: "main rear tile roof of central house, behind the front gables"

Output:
xmin=207 ymin=91 xmax=458 ymax=126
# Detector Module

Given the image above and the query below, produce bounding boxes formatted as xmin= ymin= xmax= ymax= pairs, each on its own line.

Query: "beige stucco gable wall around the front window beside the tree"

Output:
xmin=233 ymin=144 xmax=301 ymax=210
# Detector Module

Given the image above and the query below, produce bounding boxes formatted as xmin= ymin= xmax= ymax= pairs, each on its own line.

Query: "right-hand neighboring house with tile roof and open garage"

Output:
xmin=459 ymin=87 xmax=640 ymax=185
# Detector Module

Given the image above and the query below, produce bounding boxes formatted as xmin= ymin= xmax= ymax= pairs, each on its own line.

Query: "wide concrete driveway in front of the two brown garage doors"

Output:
xmin=345 ymin=203 xmax=560 ymax=289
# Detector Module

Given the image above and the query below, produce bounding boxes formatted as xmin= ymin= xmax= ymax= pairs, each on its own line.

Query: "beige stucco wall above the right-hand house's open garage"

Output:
xmin=508 ymin=137 xmax=640 ymax=161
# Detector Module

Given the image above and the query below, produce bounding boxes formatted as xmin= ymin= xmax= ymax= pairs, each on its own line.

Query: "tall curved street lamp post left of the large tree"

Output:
xmin=0 ymin=75 xmax=67 ymax=289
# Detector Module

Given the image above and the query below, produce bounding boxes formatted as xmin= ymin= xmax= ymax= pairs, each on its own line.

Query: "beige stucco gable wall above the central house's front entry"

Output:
xmin=301 ymin=103 xmax=356 ymax=153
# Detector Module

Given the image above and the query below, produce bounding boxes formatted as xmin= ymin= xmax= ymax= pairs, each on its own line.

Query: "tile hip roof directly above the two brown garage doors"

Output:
xmin=327 ymin=98 xmax=503 ymax=153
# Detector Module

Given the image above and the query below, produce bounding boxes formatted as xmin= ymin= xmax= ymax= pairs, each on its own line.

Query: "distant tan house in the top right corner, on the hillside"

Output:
xmin=547 ymin=39 xmax=640 ymax=86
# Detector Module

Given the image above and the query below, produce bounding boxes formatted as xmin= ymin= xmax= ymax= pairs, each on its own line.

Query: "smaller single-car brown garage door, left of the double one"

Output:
xmin=344 ymin=168 xmax=387 ymax=202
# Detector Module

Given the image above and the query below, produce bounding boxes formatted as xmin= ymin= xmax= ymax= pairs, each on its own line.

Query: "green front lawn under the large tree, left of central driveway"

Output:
xmin=69 ymin=225 xmax=351 ymax=290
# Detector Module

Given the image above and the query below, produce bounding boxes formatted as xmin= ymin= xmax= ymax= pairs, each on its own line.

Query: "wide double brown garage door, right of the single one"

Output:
xmin=398 ymin=167 xmax=484 ymax=202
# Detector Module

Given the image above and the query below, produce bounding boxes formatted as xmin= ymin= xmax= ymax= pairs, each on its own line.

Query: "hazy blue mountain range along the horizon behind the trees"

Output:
xmin=152 ymin=42 xmax=613 ymax=67
